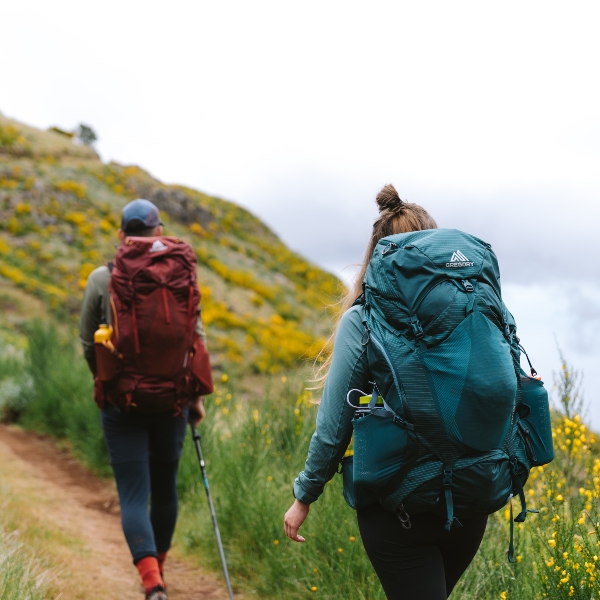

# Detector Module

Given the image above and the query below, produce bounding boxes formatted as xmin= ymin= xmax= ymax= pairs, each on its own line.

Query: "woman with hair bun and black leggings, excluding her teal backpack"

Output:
xmin=284 ymin=185 xmax=516 ymax=600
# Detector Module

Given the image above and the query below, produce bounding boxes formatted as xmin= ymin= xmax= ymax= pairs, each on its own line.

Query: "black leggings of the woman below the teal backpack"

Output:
xmin=358 ymin=504 xmax=487 ymax=600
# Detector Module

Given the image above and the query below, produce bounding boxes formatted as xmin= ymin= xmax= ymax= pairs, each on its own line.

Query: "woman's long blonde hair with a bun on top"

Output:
xmin=313 ymin=183 xmax=437 ymax=389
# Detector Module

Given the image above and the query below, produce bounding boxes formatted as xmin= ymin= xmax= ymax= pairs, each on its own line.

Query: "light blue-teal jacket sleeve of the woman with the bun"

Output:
xmin=294 ymin=306 xmax=371 ymax=504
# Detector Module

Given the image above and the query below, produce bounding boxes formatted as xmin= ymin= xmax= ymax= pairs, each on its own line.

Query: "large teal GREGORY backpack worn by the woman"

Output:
xmin=342 ymin=229 xmax=553 ymax=561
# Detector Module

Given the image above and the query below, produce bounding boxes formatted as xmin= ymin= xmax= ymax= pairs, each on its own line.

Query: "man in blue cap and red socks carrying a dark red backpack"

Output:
xmin=80 ymin=199 xmax=212 ymax=600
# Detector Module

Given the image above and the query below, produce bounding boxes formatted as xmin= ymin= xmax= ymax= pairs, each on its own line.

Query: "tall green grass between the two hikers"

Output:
xmin=178 ymin=384 xmax=384 ymax=600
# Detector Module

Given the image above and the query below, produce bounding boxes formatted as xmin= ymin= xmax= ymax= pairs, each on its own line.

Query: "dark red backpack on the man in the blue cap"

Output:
xmin=96 ymin=237 xmax=213 ymax=412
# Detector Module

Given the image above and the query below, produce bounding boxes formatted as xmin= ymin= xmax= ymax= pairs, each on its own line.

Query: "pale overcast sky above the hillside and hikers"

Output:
xmin=0 ymin=0 xmax=600 ymax=428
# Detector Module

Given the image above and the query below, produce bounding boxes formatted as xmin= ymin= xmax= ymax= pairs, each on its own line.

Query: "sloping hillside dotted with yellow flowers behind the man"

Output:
xmin=0 ymin=115 xmax=341 ymax=373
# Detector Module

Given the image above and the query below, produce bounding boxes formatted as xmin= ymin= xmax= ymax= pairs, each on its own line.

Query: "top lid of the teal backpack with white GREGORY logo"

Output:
xmin=364 ymin=229 xmax=501 ymax=315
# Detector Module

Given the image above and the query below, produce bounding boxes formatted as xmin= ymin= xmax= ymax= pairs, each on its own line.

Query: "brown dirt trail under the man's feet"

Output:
xmin=0 ymin=425 xmax=241 ymax=600
